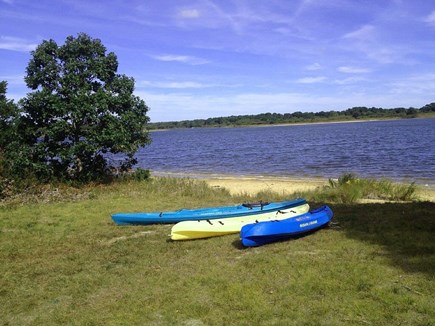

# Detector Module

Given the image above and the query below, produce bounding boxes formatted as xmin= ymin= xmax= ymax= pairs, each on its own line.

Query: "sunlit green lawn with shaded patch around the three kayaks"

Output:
xmin=0 ymin=178 xmax=435 ymax=325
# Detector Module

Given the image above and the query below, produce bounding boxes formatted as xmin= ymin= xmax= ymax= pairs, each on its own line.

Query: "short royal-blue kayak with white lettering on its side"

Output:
xmin=240 ymin=205 xmax=333 ymax=247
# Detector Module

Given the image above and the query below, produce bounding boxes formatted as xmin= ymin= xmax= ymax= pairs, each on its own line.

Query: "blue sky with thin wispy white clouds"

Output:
xmin=0 ymin=0 xmax=435 ymax=122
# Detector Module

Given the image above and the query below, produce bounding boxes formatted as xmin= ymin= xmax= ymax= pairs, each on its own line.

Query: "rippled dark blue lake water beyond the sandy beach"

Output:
xmin=137 ymin=119 xmax=435 ymax=185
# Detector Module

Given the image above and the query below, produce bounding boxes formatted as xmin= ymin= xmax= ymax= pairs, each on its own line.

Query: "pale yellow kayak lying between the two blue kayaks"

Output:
xmin=171 ymin=204 xmax=310 ymax=240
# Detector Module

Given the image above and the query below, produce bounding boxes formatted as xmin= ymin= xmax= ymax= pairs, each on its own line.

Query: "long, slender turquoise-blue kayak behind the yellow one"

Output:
xmin=112 ymin=198 xmax=306 ymax=225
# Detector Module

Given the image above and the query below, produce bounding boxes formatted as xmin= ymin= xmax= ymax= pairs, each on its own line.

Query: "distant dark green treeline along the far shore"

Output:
xmin=147 ymin=103 xmax=435 ymax=130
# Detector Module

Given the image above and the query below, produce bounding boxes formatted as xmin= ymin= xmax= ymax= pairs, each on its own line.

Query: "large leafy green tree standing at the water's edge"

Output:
xmin=18 ymin=33 xmax=150 ymax=181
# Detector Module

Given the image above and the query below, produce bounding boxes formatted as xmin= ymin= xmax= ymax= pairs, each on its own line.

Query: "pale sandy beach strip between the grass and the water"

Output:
xmin=151 ymin=173 xmax=435 ymax=202
